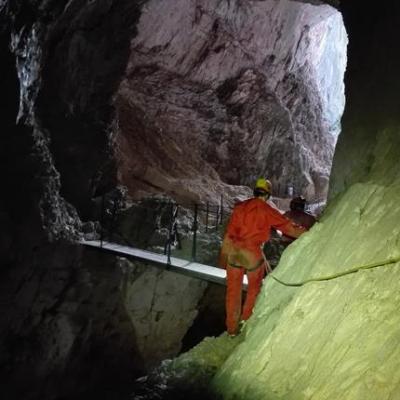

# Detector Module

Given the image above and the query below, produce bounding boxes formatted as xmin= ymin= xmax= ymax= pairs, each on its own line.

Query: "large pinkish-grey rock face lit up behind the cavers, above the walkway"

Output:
xmin=116 ymin=0 xmax=347 ymax=199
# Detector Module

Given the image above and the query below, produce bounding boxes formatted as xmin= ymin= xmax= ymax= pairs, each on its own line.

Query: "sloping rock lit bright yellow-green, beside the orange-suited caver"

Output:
xmin=214 ymin=128 xmax=400 ymax=400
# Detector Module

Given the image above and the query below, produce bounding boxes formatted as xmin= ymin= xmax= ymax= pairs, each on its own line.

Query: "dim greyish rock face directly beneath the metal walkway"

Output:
xmin=121 ymin=261 xmax=207 ymax=368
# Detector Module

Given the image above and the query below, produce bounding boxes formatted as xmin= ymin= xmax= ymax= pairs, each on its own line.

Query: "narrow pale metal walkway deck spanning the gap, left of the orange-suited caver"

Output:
xmin=79 ymin=240 xmax=247 ymax=289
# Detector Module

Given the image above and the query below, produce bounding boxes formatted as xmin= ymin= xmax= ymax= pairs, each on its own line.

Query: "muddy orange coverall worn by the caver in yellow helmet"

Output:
xmin=219 ymin=197 xmax=304 ymax=335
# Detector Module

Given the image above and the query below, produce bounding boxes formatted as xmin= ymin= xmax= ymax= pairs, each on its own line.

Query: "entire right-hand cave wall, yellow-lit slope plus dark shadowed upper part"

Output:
xmin=209 ymin=1 xmax=400 ymax=400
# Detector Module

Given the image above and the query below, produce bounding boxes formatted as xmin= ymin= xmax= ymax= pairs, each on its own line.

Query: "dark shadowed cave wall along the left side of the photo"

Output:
xmin=0 ymin=1 xmax=143 ymax=399
